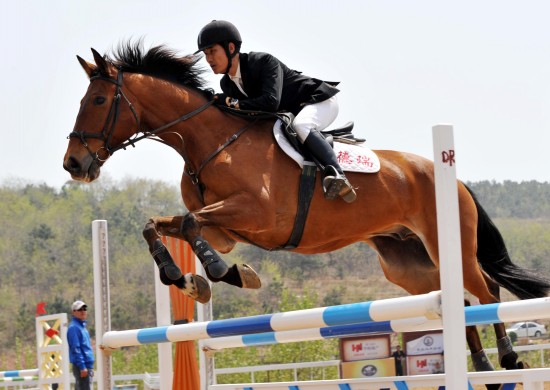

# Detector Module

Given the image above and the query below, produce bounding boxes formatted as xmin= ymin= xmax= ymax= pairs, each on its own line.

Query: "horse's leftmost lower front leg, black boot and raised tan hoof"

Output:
xmin=143 ymin=219 xmax=212 ymax=303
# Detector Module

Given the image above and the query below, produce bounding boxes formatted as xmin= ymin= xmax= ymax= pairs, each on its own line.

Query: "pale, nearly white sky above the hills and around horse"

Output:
xmin=0 ymin=0 xmax=550 ymax=187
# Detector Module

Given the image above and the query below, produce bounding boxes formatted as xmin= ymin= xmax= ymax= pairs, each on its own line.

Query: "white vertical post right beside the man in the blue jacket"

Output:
xmin=92 ymin=220 xmax=113 ymax=390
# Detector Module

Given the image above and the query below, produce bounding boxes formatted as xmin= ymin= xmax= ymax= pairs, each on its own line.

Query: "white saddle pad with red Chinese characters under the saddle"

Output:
xmin=273 ymin=121 xmax=380 ymax=173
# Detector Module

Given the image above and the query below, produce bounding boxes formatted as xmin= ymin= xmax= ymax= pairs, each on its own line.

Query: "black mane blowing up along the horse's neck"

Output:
xmin=106 ymin=40 xmax=206 ymax=89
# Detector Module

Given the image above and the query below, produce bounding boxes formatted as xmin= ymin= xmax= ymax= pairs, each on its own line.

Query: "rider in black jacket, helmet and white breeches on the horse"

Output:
xmin=195 ymin=20 xmax=356 ymax=203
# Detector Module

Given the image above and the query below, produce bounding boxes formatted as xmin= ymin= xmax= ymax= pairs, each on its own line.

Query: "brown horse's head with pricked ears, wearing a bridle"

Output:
xmin=63 ymin=49 xmax=139 ymax=182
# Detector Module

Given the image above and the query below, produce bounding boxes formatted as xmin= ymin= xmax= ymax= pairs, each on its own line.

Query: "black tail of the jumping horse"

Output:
xmin=466 ymin=186 xmax=550 ymax=299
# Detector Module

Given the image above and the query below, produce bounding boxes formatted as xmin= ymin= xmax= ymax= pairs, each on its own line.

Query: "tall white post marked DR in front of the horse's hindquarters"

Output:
xmin=432 ymin=124 xmax=468 ymax=390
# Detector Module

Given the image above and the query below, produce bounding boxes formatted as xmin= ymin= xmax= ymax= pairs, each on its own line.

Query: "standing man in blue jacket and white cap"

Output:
xmin=67 ymin=301 xmax=95 ymax=390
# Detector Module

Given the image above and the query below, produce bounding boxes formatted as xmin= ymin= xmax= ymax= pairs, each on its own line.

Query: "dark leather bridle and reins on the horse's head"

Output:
xmin=67 ymin=68 xmax=214 ymax=162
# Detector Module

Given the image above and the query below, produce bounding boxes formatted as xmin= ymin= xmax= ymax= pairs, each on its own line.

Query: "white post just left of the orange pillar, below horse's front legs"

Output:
xmin=153 ymin=264 xmax=174 ymax=390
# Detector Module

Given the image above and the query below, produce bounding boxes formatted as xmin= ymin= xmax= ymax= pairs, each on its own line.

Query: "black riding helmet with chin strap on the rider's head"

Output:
xmin=195 ymin=20 xmax=242 ymax=73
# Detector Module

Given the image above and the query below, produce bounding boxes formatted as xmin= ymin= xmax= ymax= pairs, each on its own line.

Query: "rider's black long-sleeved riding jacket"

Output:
xmin=220 ymin=52 xmax=339 ymax=115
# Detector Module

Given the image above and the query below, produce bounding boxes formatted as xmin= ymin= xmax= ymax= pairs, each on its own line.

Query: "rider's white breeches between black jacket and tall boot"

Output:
xmin=292 ymin=96 xmax=339 ymax=143
